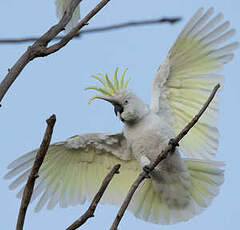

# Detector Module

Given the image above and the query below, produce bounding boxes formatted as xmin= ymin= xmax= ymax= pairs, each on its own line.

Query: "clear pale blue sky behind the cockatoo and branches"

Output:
xmin=0 ymin=0 xmax=240 ymax=230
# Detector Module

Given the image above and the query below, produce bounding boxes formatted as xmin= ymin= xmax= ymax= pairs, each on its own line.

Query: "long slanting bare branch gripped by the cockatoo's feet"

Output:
xmin=110 ymin=84 xmax=220 ymax=230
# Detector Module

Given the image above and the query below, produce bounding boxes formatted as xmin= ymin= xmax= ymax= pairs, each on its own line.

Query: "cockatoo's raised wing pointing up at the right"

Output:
xmin=152 ymin=8 xmax=238 ymax=159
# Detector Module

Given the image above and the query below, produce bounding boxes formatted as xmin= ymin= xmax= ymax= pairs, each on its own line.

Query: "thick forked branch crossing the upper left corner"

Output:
xmin=0 ymin=0 xmax=110 ymax=102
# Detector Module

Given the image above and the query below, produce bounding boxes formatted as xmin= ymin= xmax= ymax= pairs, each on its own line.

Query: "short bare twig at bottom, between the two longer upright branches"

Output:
xmin=66 ymin=164 xmax=121 ymax=230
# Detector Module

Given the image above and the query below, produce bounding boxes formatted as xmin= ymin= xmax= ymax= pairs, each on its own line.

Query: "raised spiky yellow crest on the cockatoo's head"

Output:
xmin=85 ymin=67 xmax=130 ymax=104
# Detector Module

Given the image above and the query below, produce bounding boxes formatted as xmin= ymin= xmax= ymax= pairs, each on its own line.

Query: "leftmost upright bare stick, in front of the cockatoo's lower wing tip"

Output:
xmin=16 ymin=115 xmax=56 ymax=230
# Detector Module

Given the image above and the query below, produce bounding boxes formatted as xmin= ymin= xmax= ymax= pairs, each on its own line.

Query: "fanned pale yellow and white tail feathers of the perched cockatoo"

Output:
xmin=129 ymin=159 xmax=224 ymax=224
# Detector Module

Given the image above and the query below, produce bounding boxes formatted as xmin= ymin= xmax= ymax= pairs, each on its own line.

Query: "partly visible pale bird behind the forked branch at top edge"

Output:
xmin=55 ymin=0 xmax=80 ymax=33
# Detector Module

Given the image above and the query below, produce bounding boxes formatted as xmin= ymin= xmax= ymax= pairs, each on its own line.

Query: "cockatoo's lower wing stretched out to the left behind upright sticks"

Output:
xmin=5 ymin=133 xmax=140 ymax=212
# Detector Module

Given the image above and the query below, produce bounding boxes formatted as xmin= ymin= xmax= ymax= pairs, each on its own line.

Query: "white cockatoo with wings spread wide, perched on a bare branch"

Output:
xmin=5 ymin=8 xmax=238 ymax=224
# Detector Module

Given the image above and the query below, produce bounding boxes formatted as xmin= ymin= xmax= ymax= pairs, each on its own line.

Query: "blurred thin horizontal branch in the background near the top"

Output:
xmin=0 ymin=17 xmax=181 ymax=44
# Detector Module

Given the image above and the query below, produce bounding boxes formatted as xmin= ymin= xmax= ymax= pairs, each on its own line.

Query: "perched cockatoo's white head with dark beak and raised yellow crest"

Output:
xmin=86 ymin=68 xmax=149 ymax=124
